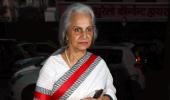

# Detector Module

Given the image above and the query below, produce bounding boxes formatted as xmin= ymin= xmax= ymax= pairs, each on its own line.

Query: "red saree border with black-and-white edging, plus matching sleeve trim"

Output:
xmin=34 ymin=52 xmax=101 ymax=100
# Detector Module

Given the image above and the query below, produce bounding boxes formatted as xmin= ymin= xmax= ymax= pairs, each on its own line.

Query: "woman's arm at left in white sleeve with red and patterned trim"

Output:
xmin=34 ymin=57 xmax=55 ymax=100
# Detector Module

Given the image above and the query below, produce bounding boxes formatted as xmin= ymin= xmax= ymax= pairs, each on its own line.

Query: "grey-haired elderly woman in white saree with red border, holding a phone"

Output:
xmin=34 ymin=3 xmax=117 ymax=100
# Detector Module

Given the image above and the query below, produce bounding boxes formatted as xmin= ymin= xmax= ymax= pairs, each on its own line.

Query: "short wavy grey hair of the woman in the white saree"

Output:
xmin=58 ymin=3 xmax=97 ymax=47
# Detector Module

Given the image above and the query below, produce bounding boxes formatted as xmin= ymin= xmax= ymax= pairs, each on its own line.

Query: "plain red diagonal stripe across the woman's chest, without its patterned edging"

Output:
xmin=51 ymin=54 xmax=97 ymax=100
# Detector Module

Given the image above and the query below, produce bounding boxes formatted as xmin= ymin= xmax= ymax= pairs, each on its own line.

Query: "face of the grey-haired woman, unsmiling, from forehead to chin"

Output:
xmin=67 ymin=12 xmax=94 ymax=50
